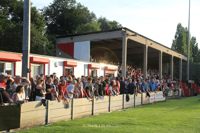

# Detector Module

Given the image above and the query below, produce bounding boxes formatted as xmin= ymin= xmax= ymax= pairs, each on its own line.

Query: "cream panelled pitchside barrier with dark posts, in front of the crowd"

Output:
xmin=0 ymin=92 xmax=165 ymax=131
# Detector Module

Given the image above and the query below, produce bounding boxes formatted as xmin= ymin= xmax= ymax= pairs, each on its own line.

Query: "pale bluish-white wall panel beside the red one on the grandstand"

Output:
xmin=74 ymin=41 xmax=90 ymax=61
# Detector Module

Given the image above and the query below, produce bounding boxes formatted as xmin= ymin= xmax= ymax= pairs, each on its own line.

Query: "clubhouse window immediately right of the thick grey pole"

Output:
xmin=31 ymin=64 xmax=44 ymax=78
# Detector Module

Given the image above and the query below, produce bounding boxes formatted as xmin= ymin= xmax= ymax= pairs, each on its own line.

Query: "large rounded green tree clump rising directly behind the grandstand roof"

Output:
xmin=44 ymin=0 xmax=121 ymax=35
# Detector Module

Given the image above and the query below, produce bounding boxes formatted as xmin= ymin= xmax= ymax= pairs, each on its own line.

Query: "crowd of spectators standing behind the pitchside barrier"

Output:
xmin=0 ymin=66 xmax=183 ymax=104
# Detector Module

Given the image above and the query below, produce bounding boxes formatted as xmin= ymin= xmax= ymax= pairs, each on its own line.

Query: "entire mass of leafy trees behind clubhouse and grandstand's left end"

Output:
xmin=0 ymin=0 xmax=121 ymax=55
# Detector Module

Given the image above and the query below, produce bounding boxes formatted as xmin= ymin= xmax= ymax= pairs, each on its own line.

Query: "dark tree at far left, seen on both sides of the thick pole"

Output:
xmin=0 ymin=0 xmax=52 ymax=54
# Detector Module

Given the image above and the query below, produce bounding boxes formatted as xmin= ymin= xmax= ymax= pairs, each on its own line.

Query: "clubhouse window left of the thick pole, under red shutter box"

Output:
xmin=0 ymin=62 xmax=14 ymax=76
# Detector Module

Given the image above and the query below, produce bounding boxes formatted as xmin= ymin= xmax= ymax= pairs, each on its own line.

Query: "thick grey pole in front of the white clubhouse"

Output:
xmin=22 ymin=0 xmax=31 ymax=78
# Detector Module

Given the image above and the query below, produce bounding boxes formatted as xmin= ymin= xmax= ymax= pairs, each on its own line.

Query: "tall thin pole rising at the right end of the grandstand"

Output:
xmin=187 ymin=0 xmax=190 ymax=81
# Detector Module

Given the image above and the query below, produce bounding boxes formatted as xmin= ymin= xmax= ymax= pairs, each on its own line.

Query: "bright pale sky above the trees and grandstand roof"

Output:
xmin=31 ymin=0 xmax=200 ymax=47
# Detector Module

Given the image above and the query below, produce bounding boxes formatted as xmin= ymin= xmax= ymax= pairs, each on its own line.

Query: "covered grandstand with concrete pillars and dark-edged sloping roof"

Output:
xmin=57 ymin=28 xmax=187 ymax=80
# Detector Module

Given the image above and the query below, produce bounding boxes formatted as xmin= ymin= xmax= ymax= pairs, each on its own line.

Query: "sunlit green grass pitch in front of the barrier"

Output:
xmin=20 ymin=96 xmax=200 ymax=133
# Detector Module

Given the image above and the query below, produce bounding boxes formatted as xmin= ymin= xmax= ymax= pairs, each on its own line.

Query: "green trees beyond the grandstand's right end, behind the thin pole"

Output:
xmin=171 ymin=23 xmax=200 ymax=63
